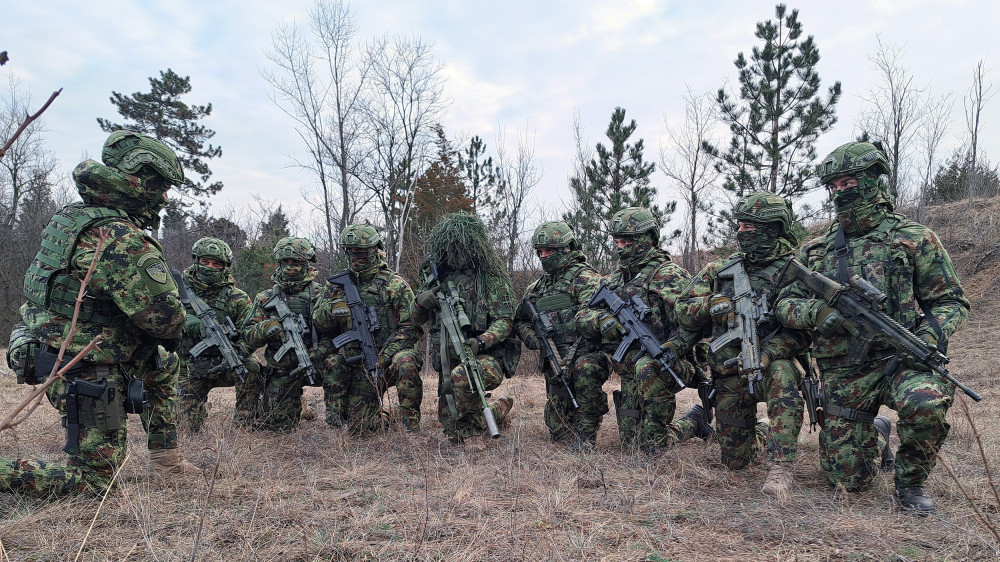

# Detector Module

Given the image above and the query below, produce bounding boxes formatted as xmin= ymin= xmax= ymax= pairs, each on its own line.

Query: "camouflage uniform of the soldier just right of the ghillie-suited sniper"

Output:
xmin=514 ymin=252 xmax=611 ymax=442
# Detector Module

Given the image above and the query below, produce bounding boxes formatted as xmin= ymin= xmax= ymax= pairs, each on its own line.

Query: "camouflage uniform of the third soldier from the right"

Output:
xmin=576 ymin=246 xmax=698 ymax=448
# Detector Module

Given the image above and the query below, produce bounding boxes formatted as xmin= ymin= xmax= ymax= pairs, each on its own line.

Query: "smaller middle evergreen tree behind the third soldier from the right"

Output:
xmin=563 ymin=107 xmax=677 ymax=271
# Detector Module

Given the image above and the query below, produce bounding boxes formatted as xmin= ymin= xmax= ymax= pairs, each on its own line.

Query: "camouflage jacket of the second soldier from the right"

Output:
xmin=674 ymin=254 xmax=809 ymax=375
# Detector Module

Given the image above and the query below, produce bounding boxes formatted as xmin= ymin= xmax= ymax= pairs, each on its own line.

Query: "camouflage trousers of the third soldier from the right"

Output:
xmin=615 ymin=352 xmax=698 ymax=451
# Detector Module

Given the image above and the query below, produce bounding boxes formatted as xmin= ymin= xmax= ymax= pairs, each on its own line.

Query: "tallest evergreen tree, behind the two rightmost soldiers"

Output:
xmin=705 ymin=4 xmax=840 ymax=210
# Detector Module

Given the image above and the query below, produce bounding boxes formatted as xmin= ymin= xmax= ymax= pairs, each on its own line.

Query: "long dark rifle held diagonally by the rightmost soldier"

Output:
xmin=779 ymin=259 xmax=983 ymax=402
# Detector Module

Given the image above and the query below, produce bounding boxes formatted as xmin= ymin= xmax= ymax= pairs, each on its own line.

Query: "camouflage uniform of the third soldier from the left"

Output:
xmin=243 ymin=266 xmax=322 ymax=432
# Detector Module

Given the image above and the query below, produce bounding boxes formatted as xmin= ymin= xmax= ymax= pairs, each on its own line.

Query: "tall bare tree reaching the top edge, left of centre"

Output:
xmin=261 ymin=0 xmax=369 ymax=262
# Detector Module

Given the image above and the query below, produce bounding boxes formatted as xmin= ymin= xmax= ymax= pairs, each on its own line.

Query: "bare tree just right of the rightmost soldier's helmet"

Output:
xmin=858 ymin=37 xmax=924 ymax=201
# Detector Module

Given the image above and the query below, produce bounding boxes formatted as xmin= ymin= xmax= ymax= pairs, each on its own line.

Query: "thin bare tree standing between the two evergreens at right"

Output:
xmin=660 ymin=88 xmax=722 ymax=272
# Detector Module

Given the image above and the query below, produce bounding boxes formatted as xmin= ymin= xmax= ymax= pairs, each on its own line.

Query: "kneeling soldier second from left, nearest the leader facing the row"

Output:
xmin=177 ymin=237 xmax=262 ymax=431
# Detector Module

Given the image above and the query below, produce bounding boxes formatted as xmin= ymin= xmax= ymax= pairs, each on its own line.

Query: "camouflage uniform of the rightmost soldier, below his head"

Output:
xmin=775 ymin=207 xmax=970 ymax=490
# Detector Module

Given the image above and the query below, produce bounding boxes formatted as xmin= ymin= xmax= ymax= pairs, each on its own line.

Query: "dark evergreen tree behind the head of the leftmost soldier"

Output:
xmin=97 ymin=68 xmax=222 ymax=208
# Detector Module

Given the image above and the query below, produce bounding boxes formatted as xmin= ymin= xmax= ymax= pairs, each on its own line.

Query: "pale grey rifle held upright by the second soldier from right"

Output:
xmin=709 ymin=260 xmax=770 ymax=395
